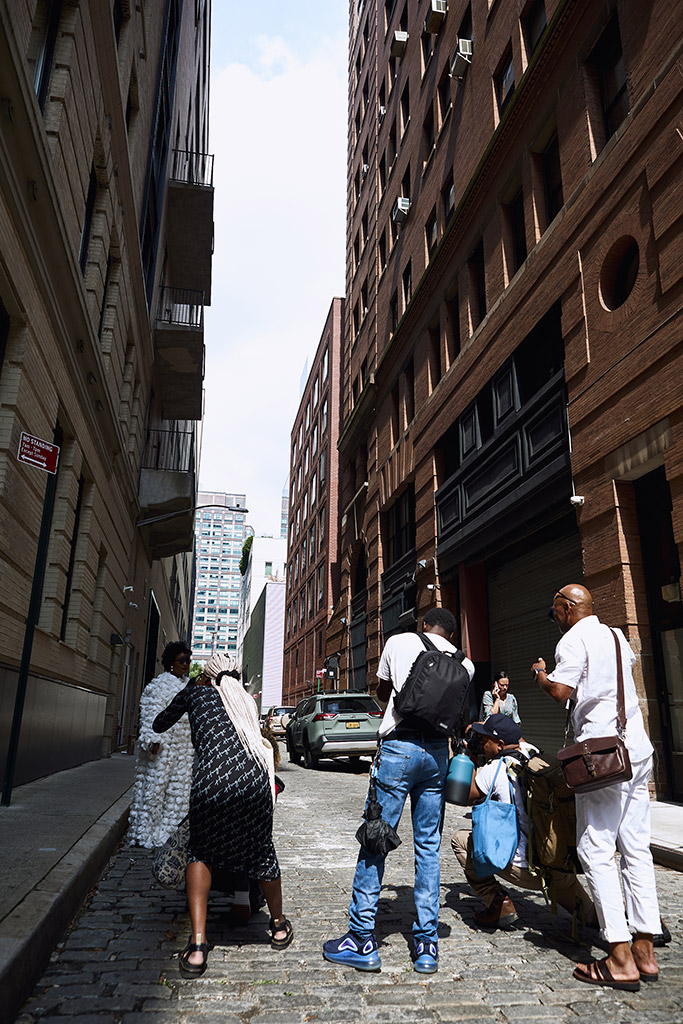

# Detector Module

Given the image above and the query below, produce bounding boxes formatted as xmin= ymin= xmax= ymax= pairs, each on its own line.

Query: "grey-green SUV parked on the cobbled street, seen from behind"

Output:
xmin=286 ymin=693 xmax=382 ymax=768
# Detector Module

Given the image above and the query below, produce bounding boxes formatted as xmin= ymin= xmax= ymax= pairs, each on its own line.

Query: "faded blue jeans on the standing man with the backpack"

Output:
xmin=349 ymin=739 xmax=449 ymax=942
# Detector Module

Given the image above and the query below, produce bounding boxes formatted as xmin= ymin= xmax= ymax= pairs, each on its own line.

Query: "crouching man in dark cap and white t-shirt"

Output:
xmin=451 ymin=714 xmax=597 ymax=928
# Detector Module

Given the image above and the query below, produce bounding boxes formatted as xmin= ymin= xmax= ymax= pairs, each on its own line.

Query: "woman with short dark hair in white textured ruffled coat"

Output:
xmin=128 ymin=642 xmax=195 ymax=849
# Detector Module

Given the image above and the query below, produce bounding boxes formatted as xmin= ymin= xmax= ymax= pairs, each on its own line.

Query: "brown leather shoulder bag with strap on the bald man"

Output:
xmin=557 ymin=628 xmax=633 ymax=793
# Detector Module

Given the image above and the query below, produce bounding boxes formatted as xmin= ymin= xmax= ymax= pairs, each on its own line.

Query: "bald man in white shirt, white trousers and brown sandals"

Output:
xmin=531 ymin=584 xmax=661 ymax=991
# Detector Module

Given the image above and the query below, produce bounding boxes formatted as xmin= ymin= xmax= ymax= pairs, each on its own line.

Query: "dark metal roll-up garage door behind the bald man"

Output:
xmin=486 ymin=529 xmax=584 ymax=755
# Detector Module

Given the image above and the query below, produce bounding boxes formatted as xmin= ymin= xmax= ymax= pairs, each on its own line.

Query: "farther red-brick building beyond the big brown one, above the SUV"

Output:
xmin=283 ymin=299 xmax=344 ymax=705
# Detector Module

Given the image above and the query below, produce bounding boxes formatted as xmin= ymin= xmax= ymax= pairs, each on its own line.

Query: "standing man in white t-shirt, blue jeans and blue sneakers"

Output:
xmin=323 ymin=608 xmax=474 ymax=974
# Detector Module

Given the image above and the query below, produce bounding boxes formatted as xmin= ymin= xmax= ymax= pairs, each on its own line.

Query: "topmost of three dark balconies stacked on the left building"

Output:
xmin=166 ymin=150 xmax=213 ymax=306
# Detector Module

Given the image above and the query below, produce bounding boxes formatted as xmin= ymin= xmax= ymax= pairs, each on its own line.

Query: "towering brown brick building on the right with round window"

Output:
xmin=330 ymin=0 xmax=683 ymax=799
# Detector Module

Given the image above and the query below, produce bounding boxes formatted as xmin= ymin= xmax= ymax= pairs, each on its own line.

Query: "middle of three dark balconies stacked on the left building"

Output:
xmin=155 ymin=288 xmax=204 ymax=420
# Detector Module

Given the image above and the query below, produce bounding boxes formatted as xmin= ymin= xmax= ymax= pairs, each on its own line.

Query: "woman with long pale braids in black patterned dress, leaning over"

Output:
xmin=153 ymin=654 xmax=294 ymax=977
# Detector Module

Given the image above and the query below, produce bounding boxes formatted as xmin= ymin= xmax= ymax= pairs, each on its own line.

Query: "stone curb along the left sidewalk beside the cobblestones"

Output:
xmin=0 ymin=787 xmax=132 ymax=1024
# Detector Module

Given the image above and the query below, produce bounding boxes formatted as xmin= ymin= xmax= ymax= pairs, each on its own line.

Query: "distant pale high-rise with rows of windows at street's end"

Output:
xmin=193 ymin=490 xmax=253 ymax=662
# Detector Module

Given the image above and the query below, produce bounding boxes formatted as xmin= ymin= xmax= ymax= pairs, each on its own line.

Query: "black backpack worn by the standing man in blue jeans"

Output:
xmin=393 ymin=633 xmax=470 ymax=736
